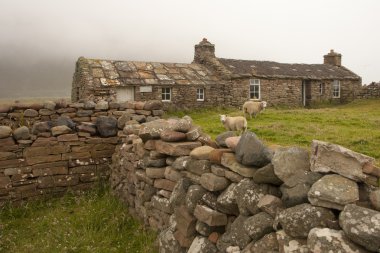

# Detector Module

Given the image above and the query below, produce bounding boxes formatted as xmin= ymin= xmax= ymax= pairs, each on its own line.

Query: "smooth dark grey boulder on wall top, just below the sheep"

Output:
xmin=235 ymin=132 xmax=272 ymax=167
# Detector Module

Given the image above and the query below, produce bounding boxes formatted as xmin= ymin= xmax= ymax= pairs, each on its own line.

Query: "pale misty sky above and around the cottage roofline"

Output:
xmin=0 ymin=0 xmax=380 ymax=98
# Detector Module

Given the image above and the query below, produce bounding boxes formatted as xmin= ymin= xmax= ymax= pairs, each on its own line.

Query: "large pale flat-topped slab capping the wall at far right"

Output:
xmin=310 ymin=140 xmax=375 ymax=181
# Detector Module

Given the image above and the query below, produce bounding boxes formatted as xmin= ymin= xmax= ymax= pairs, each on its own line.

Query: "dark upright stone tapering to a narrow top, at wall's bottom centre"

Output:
xmin=216 ymin=215 xmax=251 ymax=252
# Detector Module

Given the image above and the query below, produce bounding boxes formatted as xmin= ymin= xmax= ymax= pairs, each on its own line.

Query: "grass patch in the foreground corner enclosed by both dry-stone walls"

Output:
xmin=0 ymin=184 xmax=158 ymax=253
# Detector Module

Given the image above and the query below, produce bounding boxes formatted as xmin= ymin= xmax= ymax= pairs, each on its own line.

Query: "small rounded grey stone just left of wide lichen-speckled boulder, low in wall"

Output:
xmin=244 ymin=212 xmax=274 ymax=242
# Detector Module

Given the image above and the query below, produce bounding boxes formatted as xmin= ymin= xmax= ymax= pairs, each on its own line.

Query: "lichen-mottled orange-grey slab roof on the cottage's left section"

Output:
xmin=81 ymin=58 xmax=220 ymax=86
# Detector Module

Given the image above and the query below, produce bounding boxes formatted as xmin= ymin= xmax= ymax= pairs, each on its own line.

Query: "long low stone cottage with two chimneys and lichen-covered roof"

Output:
xmin=71 ymin=39 xmax=361 ymax=108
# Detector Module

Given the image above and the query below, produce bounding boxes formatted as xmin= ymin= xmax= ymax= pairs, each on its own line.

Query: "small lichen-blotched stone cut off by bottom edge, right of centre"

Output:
xmin=276 ymin=230 xmax=310 ymax=253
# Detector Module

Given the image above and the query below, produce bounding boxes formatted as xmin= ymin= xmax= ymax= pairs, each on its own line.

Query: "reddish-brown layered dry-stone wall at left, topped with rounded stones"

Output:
xmin=0 ymin=101 xmax=163 ymax=204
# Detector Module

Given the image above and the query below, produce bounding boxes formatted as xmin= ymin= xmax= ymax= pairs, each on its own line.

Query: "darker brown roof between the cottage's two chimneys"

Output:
xmin=218 ymin=58 xmax=360 ymax=80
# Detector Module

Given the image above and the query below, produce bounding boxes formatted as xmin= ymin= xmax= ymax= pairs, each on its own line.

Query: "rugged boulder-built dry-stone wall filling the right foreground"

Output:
xmin=111 ymin=116 xmax=380 ymax=253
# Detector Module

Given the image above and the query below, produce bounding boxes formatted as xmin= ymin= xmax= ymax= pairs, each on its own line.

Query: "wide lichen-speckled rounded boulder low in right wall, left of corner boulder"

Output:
xmin=276 ymin=204 xmax=337 ymax=238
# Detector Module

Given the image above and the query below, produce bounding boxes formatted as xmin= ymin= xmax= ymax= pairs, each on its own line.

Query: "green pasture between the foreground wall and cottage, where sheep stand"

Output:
xmin=167 ymin=100 xmax=380 ymax=159
